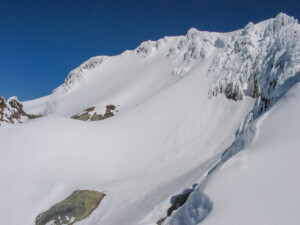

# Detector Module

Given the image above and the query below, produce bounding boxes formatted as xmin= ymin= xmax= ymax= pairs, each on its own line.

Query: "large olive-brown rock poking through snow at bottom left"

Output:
xmin=35 ymin=190 xmax=105 ymax=225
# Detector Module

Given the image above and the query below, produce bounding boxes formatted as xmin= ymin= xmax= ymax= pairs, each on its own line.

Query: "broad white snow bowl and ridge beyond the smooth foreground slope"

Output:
xmin=0 ymin=14 xmax=300 ymax=225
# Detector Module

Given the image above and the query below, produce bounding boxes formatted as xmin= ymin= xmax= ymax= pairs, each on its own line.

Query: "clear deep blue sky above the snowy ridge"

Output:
xmin=0 ymin=0 xmax=300 ymax=100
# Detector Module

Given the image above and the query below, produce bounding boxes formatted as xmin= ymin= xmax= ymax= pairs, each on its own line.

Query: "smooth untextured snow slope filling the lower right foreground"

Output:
xmin=202 ymin=85 xmax=300 ymax=225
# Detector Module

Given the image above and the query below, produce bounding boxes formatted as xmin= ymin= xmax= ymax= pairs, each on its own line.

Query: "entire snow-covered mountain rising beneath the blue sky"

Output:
xmin=0 ymin=13 xmax=300 ymax=225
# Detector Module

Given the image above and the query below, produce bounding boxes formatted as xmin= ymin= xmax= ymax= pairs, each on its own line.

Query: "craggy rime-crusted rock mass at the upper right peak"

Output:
xmin=209 ymin=13 xmax=300 ymax=110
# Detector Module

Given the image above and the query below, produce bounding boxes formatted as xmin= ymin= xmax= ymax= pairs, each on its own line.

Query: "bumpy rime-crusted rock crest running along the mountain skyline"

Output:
xmin=53 ymin=13 xmax=300 ymax=118
